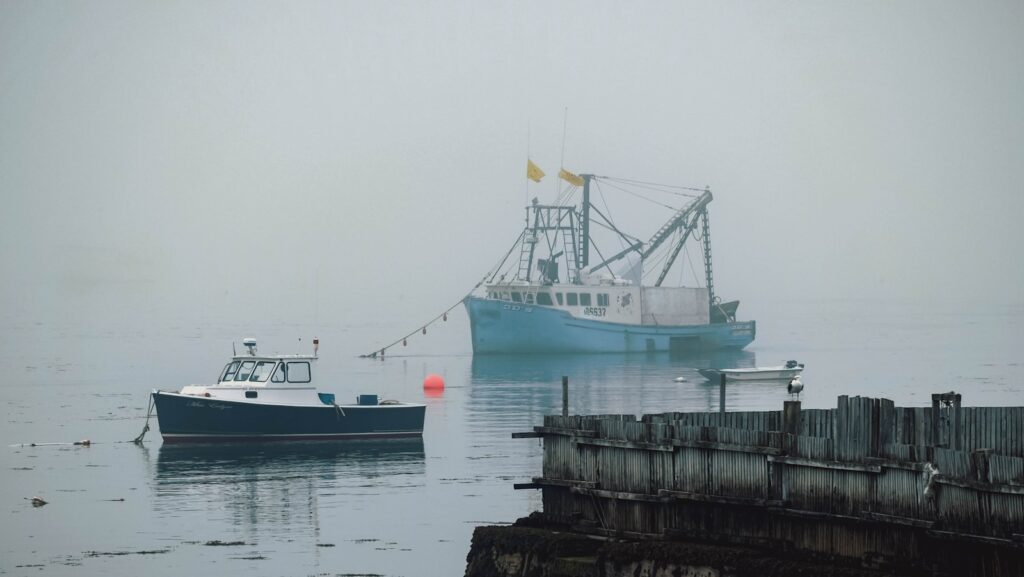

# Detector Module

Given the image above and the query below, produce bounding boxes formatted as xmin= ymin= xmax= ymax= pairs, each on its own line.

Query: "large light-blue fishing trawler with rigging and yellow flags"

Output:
xmin=464 ymin=170 xmax=757 ymax=354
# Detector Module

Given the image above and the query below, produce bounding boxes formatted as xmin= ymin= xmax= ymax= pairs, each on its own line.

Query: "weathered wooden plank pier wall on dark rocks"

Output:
xmin=513 ymin=393 xmax=1024 ymax=576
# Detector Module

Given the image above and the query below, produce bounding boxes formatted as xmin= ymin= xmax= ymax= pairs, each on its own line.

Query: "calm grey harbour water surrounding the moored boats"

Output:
xmin=0 ymin=301 xmax=1024 ymax=576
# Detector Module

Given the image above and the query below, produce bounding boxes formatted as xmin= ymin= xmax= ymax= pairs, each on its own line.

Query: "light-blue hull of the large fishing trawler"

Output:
xmin=465 ymin=296 xmax=757 ymax=355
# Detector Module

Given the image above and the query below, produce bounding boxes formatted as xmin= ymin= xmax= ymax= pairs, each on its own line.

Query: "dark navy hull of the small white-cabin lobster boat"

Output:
xmin=153 ymin=391 xmax=426 ymax=443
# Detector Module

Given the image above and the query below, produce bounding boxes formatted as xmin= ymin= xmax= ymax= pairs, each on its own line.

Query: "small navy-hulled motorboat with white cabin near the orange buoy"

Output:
xmin=152 ymin=338 xmax=426 ymax=443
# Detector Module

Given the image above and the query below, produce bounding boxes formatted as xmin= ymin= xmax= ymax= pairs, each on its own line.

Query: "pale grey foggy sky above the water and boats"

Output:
xmin=0 ymin=0 xmax=1024 ymax=339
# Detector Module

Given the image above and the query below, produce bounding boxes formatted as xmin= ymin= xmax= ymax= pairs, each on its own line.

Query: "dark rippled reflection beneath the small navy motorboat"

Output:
xmin=155 ymin=439 xmax=425 ymax=532
